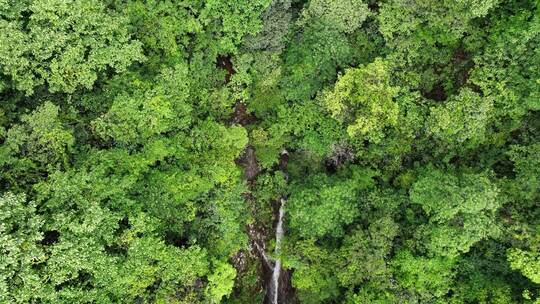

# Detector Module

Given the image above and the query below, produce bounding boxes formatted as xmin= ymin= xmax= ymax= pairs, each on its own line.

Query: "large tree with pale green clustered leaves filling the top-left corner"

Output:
xmin=0 ymin=0 xmax=144 ymax=95
